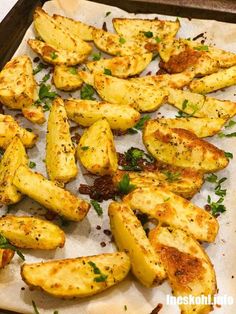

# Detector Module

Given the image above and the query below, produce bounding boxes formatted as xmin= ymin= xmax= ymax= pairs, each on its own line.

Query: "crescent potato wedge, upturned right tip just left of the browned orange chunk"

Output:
xmin=86 ymin=53 xmax=152 ymax=78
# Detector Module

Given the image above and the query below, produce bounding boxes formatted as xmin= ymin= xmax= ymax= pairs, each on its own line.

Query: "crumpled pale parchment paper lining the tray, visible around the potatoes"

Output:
xmin=0 ymin=0 xmax=236 ymax=314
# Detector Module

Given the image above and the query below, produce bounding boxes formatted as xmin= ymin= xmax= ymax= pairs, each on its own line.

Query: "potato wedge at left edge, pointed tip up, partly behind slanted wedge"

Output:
xmin=0 ymin=136 xmax=28 ymax=205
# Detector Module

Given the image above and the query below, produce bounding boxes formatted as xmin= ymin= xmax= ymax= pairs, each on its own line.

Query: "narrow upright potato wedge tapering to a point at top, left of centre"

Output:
xmin=46 ymin=97 xmax=78 ymax=183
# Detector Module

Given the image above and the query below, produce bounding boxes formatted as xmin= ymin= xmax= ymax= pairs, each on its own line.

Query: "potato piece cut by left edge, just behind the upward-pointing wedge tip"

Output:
xmin=0 ymin=114 xmax=38 ymax=149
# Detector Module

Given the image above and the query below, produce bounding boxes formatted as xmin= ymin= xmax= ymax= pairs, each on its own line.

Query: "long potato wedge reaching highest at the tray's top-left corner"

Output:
xmin=34 ymin=7 xmax=92 ymax=55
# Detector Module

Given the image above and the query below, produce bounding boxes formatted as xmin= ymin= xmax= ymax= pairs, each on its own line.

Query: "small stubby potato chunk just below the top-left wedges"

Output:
xmin=53 ymin=65 xmax=83 ymax=92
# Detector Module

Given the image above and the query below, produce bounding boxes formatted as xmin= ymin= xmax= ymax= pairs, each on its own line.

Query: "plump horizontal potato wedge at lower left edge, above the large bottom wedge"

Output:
xmin=0 ymin=215 xmax=65 ymax=250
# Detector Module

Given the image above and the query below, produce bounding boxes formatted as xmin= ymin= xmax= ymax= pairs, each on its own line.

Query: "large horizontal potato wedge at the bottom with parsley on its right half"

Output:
xmin=21 ymin=252 xmax=130 ymax=298
